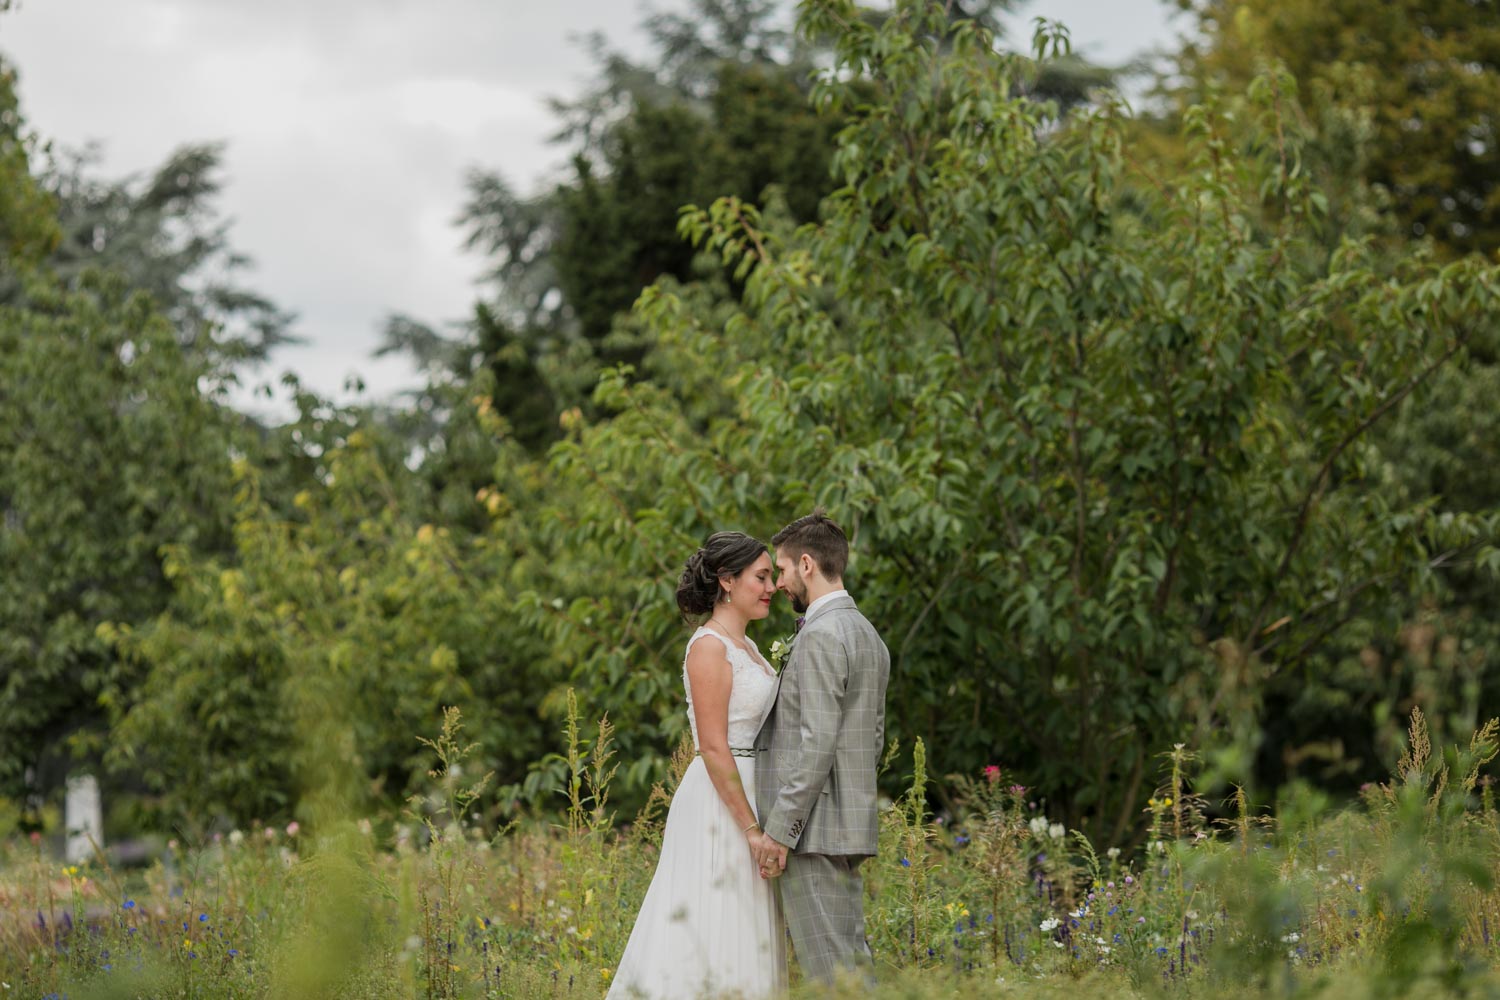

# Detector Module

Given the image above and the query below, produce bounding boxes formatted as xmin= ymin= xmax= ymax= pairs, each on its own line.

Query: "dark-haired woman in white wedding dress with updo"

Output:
xmin=609 ymin=531 xmax=786 ymax=1000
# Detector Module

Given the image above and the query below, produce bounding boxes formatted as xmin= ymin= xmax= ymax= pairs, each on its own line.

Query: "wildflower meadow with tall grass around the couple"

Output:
xmin=0 ymin=712 xmax=1500 ymax=999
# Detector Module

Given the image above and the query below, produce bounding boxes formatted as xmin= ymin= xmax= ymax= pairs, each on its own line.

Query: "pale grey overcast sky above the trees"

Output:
xmin=0 ymin=0 xmax=1173 ymax=419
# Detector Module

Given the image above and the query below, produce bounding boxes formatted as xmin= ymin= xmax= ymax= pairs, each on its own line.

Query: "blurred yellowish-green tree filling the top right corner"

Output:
xmin=1179 ymin=0 xmax=1500 ymax=253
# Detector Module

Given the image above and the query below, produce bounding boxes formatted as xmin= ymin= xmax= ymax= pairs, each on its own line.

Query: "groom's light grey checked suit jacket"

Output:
xmin=755 ymin=597 xmax=891 ymax=856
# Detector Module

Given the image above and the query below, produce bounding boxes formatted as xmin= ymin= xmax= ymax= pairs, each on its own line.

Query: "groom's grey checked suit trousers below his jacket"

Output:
xmin=777 ymin=853 xmax=875 ymax=984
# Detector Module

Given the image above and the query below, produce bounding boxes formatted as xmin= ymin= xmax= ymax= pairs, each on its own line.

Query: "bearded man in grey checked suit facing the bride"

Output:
xmin=750 ymin=510 xmax=891 ymax=982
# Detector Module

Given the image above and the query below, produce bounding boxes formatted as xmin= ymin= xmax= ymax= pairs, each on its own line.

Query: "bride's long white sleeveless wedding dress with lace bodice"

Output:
xmin=609 ymin=627 xmax=786 ymax=1000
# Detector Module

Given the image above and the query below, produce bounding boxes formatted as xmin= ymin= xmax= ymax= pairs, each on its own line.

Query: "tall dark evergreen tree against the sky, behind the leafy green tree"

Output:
xmin=383 ymin=0 xmax=1110 ymax=476
